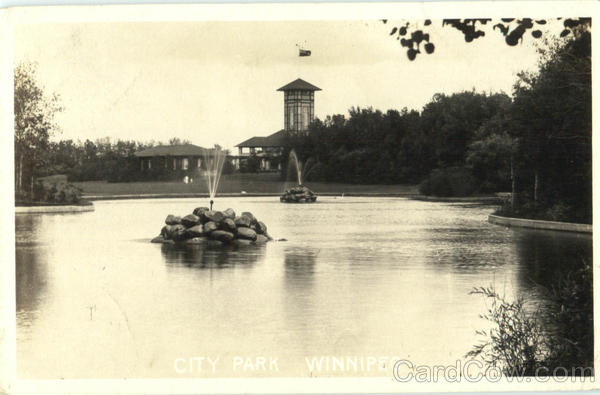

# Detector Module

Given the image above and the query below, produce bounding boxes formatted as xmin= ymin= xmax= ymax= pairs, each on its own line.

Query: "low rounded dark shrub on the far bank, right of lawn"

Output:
xmin=419 ymin=167 xmax=477 ymax=197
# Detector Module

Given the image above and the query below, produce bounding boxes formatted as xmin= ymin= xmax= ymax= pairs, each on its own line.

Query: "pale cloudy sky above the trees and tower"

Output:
xmin=14 ymin=20 xmax=556 ymax=149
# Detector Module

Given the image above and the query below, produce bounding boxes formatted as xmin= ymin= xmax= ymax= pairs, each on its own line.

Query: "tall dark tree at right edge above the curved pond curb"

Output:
xmin=512 ymin=29 xmax=592 ymax=221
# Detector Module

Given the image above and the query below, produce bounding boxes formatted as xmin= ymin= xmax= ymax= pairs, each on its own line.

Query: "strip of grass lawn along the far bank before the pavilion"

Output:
xmin=73 ymin=174 xmax=418 ymax=196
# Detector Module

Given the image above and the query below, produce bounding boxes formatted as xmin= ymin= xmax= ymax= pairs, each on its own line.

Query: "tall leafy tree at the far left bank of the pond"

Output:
xmin=14 ymin=63 xmax=62 ymax=197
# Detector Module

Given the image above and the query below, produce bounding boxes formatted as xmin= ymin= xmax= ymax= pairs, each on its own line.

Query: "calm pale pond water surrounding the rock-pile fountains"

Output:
xmin=16 ymin=197 xmax=592 ymax=378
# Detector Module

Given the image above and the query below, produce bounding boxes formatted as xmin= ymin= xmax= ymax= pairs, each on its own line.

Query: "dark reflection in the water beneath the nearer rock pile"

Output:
xmin=160 ymin=244 xmax=265 ymax=269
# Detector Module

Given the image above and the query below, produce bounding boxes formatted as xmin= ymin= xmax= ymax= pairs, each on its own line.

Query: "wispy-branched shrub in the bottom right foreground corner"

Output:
xmin=466 ymin=262 xmax=594 ymax=376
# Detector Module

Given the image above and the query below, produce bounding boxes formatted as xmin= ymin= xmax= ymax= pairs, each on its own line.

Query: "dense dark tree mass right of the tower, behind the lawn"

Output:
xmin=290 ymin=92 xmax=510 ymax=188
